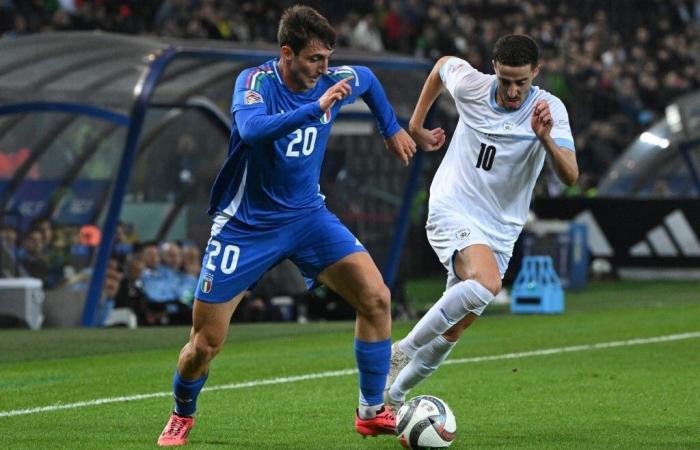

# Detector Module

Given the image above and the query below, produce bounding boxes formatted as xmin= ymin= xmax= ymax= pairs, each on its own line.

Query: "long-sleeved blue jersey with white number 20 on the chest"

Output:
xmin=209 ymin=60 xmax=400 ymax=227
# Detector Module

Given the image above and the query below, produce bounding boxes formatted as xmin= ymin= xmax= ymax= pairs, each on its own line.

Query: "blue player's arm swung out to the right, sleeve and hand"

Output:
xmin=353 ymin=67 xmax=416 ymax=165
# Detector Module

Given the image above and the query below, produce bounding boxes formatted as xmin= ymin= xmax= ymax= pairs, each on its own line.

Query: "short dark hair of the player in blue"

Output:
xmin=277 ymin=5 xmax=336 ymax=53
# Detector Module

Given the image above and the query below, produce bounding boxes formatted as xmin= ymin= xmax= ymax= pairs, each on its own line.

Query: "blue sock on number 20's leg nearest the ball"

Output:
xmin=355 ymin=337 xmax=391 ymax=406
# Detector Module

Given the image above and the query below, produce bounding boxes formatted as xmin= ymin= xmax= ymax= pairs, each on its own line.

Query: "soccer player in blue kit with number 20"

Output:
xmin=158 ymin=5 xmax=416 ymax=446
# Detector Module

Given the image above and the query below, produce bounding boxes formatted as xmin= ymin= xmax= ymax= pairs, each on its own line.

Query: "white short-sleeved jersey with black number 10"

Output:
xmin=430 ymin=58 xmax=575 ymax=255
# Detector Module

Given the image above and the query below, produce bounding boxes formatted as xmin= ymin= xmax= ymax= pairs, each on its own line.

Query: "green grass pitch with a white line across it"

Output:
xmin=0 ymin=281 xmax=700 ymax=449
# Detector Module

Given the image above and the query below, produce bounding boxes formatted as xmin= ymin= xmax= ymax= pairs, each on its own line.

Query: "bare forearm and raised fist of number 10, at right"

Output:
xmin=530 ymin=100 xmax=578 ymax=186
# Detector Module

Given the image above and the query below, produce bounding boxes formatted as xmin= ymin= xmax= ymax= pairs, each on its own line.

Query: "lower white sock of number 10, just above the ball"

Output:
xmin=389 ymin=336 xmax=456 ymax=401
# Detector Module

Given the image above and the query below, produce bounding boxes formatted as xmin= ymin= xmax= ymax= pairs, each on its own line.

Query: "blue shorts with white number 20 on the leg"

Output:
xmin=195 ymin=208 xmax=366 ymax=303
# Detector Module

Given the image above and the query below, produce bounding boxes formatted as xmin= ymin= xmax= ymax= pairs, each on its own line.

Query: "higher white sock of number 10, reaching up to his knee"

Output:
xmin=398 ymin=280 xmax=493 ymax=358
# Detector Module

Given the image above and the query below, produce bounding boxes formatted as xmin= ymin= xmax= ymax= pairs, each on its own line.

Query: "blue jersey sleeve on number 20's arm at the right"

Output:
xmin=334 ymin=66 xmax=401 ymax=138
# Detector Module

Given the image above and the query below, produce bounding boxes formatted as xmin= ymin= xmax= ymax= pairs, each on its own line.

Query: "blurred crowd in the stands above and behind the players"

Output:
xmin=0 ymin=0 xmax=700 ymax=195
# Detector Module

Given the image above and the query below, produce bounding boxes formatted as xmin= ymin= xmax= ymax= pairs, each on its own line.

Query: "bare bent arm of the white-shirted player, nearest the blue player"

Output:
xmin=408 ymin=56 xmax=451 ymax=151
